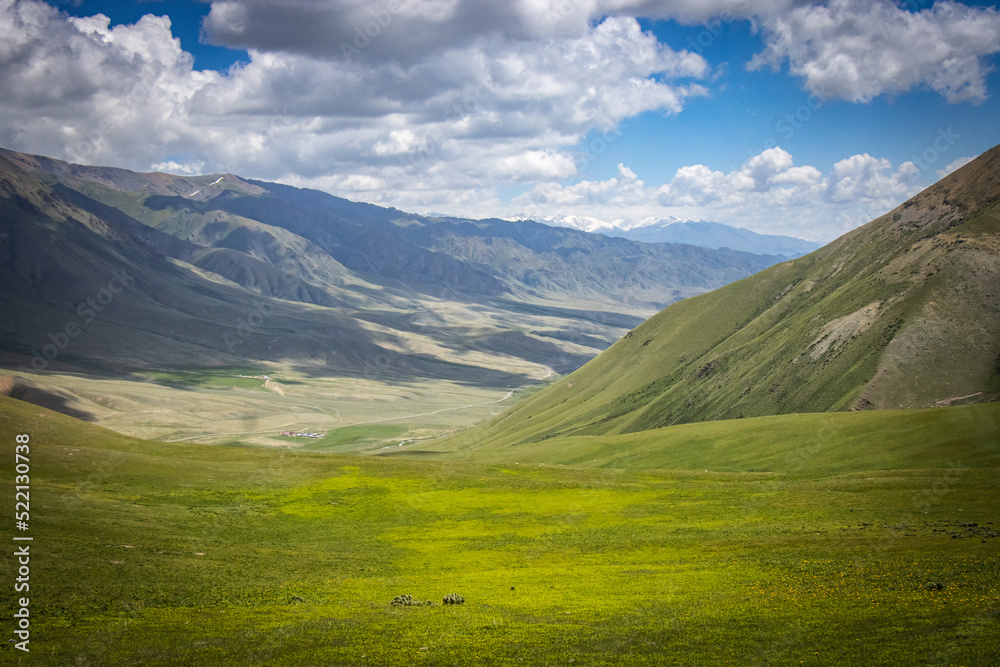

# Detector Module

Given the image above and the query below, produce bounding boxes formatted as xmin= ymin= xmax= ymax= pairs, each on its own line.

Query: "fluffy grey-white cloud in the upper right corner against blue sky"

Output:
xmin=750 ymin=0 xmax=1000 ymax=102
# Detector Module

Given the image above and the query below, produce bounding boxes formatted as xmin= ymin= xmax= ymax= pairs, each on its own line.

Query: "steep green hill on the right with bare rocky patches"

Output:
xmin=438 ymin=147 xmax=1000 ymax=449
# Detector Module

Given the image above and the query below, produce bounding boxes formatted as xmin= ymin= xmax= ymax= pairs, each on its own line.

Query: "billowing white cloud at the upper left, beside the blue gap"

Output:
xmin=0 ymin=1 xmax=220 ymax=167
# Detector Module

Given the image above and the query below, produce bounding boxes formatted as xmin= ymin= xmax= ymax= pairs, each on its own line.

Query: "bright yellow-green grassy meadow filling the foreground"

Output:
xmin=0 ymin=399 xmax=1000 ymax=665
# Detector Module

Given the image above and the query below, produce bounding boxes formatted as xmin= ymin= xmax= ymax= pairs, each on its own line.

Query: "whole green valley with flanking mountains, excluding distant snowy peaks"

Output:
xmin=0 ymin=144 xmax=1000 ymax=666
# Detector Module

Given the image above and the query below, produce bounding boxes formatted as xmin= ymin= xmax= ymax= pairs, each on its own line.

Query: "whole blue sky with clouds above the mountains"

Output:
xmin=0 ymin=0 xmax=1000 ymax=242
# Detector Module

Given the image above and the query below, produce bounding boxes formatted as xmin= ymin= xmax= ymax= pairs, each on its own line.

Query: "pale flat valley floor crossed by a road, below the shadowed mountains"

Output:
xmin=0 ymin=364 xmax=552 ymax=453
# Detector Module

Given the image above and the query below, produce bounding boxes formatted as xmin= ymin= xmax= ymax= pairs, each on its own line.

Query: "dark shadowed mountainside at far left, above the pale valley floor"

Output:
xmin=0 ymin=155 xmax=398 ymax=371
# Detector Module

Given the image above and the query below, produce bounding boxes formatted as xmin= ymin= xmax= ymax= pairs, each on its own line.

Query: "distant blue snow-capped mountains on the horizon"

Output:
xmin=540 ymin=216 xmax=820 ymax=257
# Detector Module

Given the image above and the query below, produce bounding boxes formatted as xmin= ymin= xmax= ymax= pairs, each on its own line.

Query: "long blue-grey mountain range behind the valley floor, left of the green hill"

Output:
xmin=0 ymin=149 xmax=777 ymax=386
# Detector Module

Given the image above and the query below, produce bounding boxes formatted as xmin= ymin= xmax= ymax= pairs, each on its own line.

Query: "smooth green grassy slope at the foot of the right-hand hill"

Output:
xmin=416 ymin=402 xmax=1000 ymax=476
